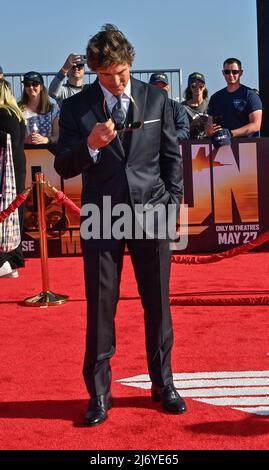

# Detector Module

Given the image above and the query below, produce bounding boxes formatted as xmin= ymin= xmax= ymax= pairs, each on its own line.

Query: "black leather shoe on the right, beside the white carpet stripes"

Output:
xmin=151 ymin=384 xmax=187 ymax=413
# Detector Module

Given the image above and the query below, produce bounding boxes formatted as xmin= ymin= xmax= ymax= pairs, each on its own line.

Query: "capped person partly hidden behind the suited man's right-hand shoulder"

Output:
xmin=149 ymin=72 xmax=190 ymax=141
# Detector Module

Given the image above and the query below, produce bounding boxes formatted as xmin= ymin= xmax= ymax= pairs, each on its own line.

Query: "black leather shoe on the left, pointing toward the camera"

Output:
xmin=84 ymin=392 xmax=112 ymax=426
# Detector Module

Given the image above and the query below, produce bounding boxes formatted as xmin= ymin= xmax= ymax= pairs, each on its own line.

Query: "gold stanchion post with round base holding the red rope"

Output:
xmin=24 ymin=173 xmax=68 ymax=307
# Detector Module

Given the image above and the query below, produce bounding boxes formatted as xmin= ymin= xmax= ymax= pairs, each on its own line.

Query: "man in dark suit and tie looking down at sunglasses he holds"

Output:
xmin=55 ymin=25 xmax=186 ymax=426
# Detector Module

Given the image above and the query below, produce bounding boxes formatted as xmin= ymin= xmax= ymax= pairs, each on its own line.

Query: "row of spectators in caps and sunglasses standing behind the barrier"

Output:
xmin=0 ymin=53 xmax=262 ymax=152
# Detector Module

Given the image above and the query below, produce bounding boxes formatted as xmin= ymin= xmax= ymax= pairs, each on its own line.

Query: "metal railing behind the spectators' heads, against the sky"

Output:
xmin=5 ymin=69 xmax=183 ymax=101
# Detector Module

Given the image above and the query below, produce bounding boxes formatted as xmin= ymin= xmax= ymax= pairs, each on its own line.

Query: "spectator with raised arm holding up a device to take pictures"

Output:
xmin=49 ymin=53 xmax=86 ymax=107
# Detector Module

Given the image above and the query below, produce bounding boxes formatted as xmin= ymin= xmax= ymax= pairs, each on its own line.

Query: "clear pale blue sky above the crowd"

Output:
xmin=0 ymin=0 xmax=258 ymax=99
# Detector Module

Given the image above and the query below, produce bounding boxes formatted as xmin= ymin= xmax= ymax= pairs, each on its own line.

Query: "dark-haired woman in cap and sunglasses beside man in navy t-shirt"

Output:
xmin=182 ymin=72 xmax=208 ymax=139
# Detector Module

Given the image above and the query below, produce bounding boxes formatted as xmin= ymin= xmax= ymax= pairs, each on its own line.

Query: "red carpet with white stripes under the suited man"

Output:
xmin=0 ymin=253 xmax=269 ymax=450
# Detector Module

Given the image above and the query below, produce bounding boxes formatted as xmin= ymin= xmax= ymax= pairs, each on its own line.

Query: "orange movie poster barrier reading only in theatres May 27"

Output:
xmin=23 ymin=138 xmax=269 ymax=257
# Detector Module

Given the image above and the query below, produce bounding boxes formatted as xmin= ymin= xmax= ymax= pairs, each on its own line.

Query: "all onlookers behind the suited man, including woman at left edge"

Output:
xmin=0 ymin=53 xmax=262 ymax=277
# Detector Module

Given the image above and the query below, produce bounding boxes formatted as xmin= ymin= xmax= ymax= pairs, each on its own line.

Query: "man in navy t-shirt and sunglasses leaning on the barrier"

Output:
xmin=207 ymin=57 xmax=262 ymax=137
